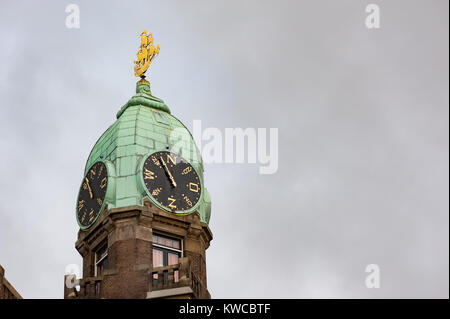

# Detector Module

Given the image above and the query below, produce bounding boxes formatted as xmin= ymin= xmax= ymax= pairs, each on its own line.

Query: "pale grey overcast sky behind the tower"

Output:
xmin=0 ymin=0 xmax=449 ymax=298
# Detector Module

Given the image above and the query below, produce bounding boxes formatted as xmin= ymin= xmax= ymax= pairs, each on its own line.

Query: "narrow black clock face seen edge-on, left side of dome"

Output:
xmin=77 ymin=162 xmax=108 ymax=228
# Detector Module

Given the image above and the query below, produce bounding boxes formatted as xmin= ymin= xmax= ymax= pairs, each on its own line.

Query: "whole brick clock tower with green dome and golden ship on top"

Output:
xmin=64 ymin=30 xmax=212 ymax=298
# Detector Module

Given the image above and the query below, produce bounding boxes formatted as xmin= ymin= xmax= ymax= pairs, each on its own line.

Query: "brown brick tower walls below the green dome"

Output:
xmin=64 ymin=199 xmax=212 ymax=299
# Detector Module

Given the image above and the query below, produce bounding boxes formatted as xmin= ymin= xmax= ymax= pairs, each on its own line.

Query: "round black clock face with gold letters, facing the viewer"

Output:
xmin=142 ymin=152 xmax=202 ymax=211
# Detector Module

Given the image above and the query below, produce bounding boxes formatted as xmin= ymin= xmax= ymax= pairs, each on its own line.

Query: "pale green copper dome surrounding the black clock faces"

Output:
xmin=85 ymin=80 xmax=211 ymax=223
